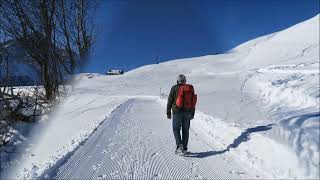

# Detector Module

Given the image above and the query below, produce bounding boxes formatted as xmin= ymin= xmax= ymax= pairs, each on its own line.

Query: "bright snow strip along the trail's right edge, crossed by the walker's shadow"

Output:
xmin=159 ymin=100 xmax=304 ymax=179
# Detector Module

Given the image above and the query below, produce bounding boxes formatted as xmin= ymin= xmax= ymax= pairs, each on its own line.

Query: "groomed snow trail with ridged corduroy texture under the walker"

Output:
xmin=52 ymin=98 xmax=261 ymax=179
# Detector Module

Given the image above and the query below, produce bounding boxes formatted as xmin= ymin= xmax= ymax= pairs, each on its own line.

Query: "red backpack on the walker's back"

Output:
xmin=176 ymin=84 xmax=197 ymax=110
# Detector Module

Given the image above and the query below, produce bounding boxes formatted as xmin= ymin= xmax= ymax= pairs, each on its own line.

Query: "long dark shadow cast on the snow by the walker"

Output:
xmin=185 ymin=124 xmax=275 ymax=158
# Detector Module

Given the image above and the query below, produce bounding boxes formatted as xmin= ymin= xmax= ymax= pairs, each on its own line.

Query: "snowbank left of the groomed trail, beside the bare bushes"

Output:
xmin=1 ymin=92 xmax=126 ymax=179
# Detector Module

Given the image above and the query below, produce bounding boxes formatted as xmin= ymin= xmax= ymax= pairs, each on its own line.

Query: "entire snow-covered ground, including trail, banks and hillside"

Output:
xmin=1 ymin=15 xmax=320 ymax=179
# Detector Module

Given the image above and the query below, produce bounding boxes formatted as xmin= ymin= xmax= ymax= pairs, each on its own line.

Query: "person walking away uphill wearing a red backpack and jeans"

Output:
xmin=167 ymin=74 xmax=197 ymax=154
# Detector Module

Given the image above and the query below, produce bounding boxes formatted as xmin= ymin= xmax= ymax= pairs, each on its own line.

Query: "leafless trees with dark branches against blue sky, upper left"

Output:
xmin=0 ymin=0 xmax=95 ymax=101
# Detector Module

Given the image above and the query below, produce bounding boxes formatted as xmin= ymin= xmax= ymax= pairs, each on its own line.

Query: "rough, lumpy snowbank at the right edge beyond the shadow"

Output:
xmin=242 ymin=60 xmax=320 ymax=178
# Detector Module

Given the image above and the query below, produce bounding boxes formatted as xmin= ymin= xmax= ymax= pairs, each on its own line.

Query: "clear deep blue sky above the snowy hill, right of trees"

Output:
xmin=84 ymin=0 xmax=319 ymax=73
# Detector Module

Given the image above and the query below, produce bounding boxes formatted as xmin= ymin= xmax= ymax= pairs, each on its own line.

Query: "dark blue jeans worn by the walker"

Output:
xmin=172 ymin=112 xmax=192 ymax=150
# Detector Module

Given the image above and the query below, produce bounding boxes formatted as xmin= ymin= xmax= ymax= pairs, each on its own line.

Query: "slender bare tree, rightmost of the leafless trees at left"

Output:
xmin=57 ymin=0 xmax=96 ymax=74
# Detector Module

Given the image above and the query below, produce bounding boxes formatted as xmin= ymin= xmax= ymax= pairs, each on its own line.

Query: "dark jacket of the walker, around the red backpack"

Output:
xmin=167 ymin=84 xmax=195 ymax=115
